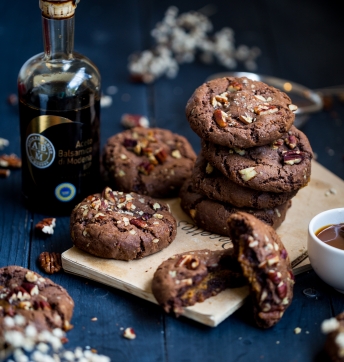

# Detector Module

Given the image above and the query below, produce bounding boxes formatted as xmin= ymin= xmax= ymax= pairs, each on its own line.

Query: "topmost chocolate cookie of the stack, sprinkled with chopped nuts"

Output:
xmin=186 ymin=77 xmax=297 ymax=148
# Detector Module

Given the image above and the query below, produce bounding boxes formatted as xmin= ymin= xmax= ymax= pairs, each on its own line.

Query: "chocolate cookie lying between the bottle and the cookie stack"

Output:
xmin=103 ymin=127 xmax=196 ymax=197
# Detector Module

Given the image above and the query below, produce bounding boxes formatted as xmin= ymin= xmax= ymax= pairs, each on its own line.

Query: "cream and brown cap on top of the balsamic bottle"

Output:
xmin=39 ymin=0 xmax=80 ymax=19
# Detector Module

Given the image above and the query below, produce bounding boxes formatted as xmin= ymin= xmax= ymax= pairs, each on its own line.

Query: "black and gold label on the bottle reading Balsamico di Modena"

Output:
xmin=25 ymin=115 xmax=93 ymax=202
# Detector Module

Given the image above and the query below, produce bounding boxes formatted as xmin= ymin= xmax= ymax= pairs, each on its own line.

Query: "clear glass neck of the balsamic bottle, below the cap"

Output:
xmin=42 ymin=16 xmax=74 ymax=60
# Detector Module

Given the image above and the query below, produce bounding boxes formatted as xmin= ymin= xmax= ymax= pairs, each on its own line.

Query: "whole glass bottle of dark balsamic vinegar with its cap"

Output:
xmin=18 ymin=0 xmax=101 ymax=214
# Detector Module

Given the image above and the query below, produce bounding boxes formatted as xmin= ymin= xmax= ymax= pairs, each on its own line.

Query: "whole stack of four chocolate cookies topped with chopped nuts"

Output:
xmin=180 ymin=77 xmax=312 ymax=235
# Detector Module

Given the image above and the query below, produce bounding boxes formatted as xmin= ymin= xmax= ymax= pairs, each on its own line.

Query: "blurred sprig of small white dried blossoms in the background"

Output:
xmin=128 ymin=6 xmax=260 ymax=83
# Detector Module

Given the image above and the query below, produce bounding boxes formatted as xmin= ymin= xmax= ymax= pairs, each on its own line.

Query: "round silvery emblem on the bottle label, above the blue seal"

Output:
xmin=26 ymin=133 xmax=55 ymax=168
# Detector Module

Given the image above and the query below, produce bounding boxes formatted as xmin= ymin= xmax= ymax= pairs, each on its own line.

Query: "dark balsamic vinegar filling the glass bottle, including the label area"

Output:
xmin=19 ymin=82 xmax=100 ymax=214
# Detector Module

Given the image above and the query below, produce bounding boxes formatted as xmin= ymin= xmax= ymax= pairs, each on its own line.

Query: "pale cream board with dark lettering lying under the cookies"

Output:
xmin=62 ymin=161 xmax=344 ymax=327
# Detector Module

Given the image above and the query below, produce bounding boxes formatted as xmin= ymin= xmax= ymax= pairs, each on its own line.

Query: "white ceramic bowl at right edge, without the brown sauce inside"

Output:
xmin=308 ymin=208 xmax=344 ymax=293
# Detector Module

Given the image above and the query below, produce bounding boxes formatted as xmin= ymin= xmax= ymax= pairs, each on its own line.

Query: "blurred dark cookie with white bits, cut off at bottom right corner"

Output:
xmin=321 ymin=313 xmax=344 ymax=362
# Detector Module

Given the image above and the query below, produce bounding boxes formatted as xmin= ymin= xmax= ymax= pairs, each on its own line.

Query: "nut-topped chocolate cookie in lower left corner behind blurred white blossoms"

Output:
xmin=0 ymin=265 xmax=74 ymax=349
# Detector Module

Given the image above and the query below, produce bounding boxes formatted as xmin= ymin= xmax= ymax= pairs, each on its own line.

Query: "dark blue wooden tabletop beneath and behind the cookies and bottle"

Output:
xmin=0 ymin=0 xmax=344 ymax=362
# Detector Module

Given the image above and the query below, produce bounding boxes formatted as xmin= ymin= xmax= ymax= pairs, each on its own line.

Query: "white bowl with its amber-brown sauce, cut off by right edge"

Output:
xmin=307 ymin=208 xmax=344 ymax=293
